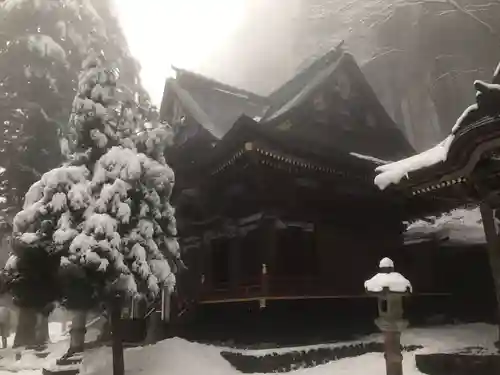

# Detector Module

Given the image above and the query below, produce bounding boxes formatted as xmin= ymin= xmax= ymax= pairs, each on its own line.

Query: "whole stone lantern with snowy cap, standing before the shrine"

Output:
xmin=365 ymin=258 xmax=412 ymax=375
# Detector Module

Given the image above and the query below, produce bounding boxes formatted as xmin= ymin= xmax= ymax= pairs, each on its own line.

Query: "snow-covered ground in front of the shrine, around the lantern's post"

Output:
xmin=80 ymin=323 xmax=497 ymax=375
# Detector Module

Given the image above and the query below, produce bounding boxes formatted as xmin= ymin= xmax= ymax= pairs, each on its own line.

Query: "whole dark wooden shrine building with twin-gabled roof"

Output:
xmin=161 ymin=44 xmax=490 ymax=334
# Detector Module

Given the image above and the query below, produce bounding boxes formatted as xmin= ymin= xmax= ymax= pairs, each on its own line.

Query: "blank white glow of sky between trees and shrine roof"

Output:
xmin=115 ymin=0 xmax=251 ymax=104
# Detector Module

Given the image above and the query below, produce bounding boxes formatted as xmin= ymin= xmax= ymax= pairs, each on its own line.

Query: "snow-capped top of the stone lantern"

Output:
xmin=365 ymin=258 xmax=412 ymax=293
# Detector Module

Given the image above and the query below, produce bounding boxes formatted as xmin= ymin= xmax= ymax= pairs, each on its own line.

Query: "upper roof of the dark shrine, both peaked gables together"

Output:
xmin=161 ymin=48 xmax=414 ymax=170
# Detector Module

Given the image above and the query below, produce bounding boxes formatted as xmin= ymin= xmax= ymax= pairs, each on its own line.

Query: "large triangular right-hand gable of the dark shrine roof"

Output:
xmin=261 ymin=50 xmax=414 ymax=160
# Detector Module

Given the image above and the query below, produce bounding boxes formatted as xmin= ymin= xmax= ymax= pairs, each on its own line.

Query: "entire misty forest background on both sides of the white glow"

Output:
xmin=0 ymin=0 xmax=500 ymax=264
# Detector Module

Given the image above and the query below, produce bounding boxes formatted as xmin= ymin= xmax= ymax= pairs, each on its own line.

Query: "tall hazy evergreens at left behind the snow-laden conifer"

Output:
xmin=0 ymin=0 xmax=147 ymax=239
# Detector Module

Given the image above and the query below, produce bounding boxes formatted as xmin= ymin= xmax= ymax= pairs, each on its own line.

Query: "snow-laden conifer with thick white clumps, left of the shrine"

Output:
xmin=6 ymin=50 xmax=182 ymax=326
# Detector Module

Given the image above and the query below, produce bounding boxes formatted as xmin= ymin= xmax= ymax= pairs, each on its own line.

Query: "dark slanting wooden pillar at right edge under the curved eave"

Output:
xmin=479 ymin=203 xmax=500 ymax=346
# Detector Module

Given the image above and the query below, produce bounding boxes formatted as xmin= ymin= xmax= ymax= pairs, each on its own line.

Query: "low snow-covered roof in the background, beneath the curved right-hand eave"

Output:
xmin=404 ymin=208 xmax=486 ymax=245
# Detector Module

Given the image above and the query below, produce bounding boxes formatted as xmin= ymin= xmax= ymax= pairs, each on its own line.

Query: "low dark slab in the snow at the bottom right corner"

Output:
xmin=415 ymin=348 xmax=500 ymax=375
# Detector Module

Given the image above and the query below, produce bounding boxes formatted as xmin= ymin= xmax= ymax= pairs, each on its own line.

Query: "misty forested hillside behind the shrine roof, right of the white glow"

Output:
xmin=202 ymin=0 xmax=500 ymax=151
